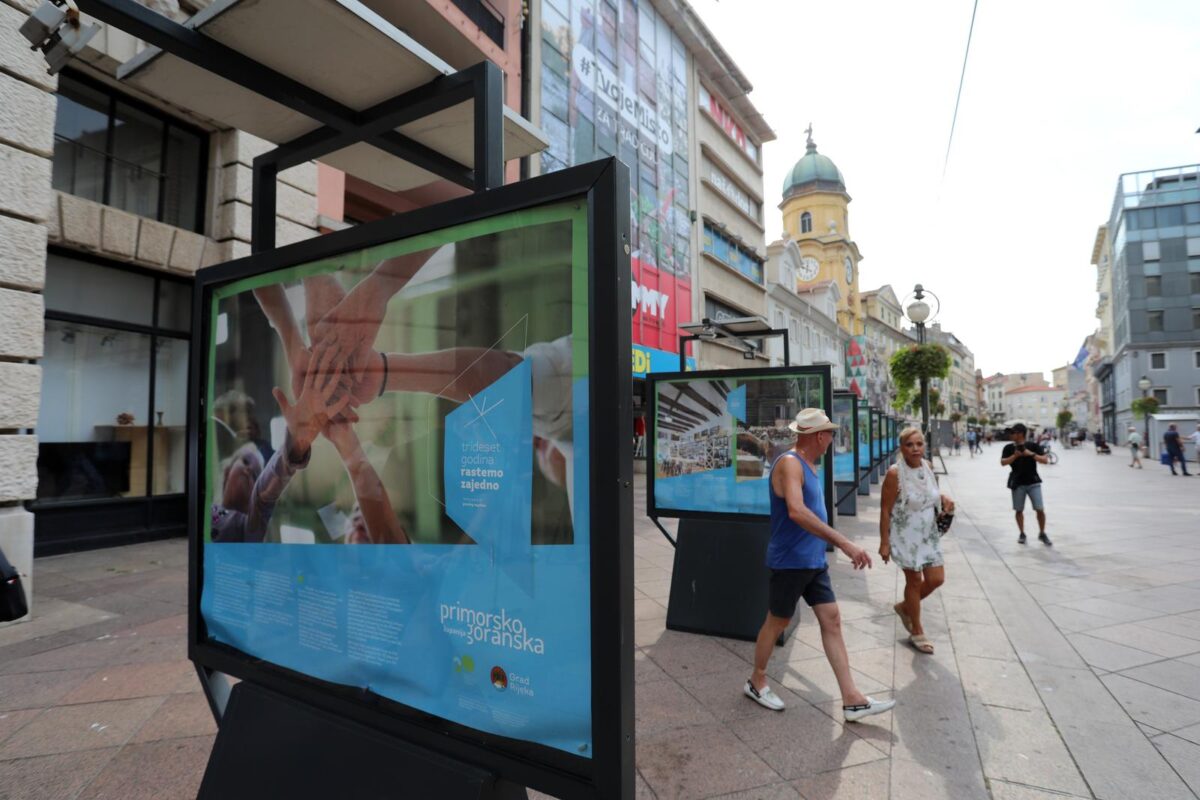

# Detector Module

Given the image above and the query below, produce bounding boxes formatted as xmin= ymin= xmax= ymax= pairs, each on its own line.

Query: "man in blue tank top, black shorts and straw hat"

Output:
xmin=743 ymin=408 xmax=895 ymax=722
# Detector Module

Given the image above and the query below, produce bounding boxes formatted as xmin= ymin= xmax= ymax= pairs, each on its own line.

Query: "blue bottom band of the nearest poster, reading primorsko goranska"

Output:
xmin=200 ymin=543 xmax=592 ymax=757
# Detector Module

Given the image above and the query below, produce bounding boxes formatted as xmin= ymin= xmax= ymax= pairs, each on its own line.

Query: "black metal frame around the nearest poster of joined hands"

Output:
xmin=188 ymin=158 xmax=634 ymax=799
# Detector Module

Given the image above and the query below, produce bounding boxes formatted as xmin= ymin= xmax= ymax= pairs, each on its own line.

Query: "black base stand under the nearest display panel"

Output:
xmin=197 ymin=681 xmax=527 ymax=800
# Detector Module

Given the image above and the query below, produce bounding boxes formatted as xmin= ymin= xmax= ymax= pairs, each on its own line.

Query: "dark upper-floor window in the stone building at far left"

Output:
xmin=50 ymin=73 xmax=208 ymax=231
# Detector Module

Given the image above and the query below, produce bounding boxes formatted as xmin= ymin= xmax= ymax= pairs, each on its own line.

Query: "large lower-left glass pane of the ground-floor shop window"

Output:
xmin=37 ymin=320 xmax=150 ymax=500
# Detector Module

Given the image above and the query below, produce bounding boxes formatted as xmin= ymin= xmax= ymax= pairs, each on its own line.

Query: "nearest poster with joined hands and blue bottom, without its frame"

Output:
xmin=200 ymin=200 xmax=593 ymax=758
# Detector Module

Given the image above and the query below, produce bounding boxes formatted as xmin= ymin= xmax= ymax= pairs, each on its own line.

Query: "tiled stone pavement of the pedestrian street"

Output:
xmin=0 ymin=447 xmax=1200 ymax=800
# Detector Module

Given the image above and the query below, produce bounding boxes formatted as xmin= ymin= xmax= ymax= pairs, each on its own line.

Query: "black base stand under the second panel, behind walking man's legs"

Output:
xmin=667 ymin=519 xmax=800 ymax=644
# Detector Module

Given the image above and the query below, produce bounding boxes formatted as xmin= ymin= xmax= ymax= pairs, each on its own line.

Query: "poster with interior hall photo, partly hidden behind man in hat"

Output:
xmin=653 ymin=374 xmax=828 ymax=516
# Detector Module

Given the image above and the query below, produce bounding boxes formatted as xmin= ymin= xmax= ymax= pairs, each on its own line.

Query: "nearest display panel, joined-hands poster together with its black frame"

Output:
xmin=188 ymin=160 xmax=634 ymax=798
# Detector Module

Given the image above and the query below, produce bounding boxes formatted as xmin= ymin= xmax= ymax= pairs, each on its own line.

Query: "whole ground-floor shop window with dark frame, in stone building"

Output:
xmin=37 ymin=251 xmax=192 ymax=505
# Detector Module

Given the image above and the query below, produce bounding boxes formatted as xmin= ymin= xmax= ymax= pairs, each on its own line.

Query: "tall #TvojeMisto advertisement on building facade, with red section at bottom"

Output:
xmin=541 ymin=0 xmax=692 ymax=353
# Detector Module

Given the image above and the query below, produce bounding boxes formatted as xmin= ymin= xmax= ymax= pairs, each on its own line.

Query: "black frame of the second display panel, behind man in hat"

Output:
xmin=646 ymin=365 xmax=834 ymax=527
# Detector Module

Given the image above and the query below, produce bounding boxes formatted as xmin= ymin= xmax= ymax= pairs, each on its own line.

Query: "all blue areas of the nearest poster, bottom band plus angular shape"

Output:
xmin=200 ymin=367 xmax=593 ymax=758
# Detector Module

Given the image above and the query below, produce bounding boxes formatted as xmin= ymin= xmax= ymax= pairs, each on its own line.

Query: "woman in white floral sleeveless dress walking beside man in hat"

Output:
xmin=880 ymin=428 xmax=954 ymax=654
